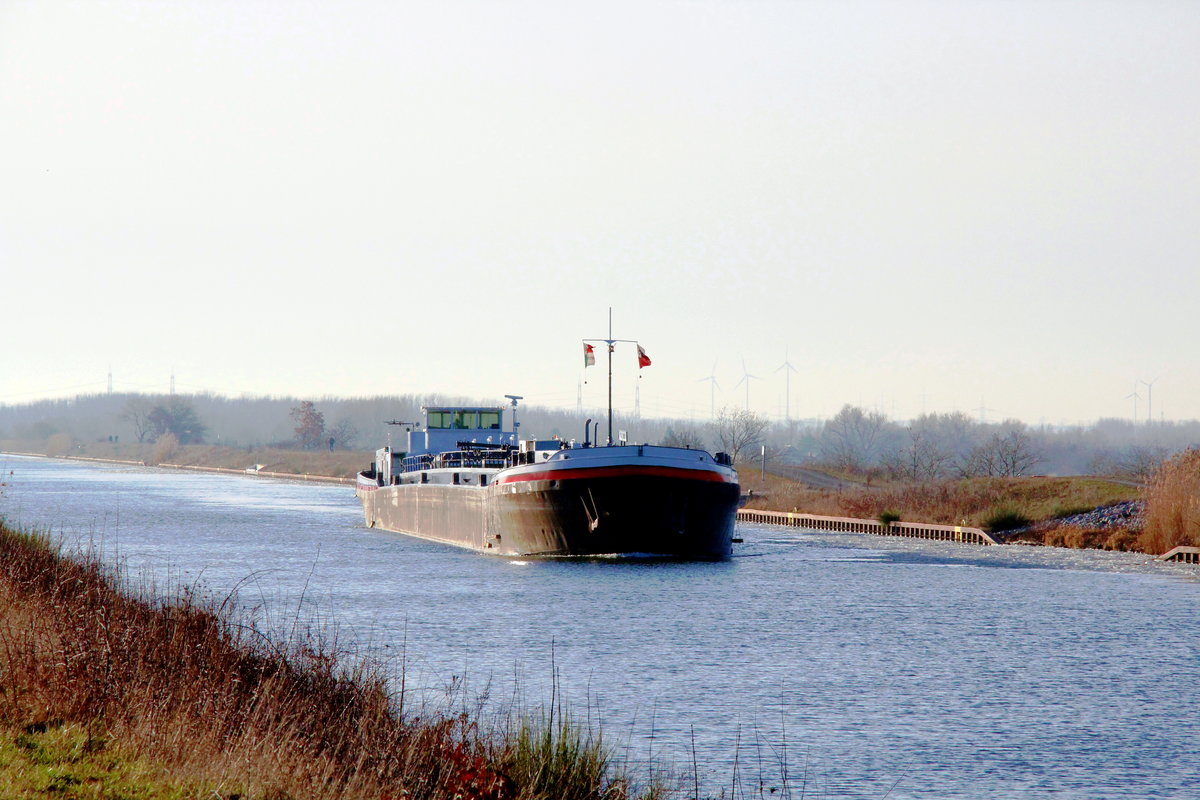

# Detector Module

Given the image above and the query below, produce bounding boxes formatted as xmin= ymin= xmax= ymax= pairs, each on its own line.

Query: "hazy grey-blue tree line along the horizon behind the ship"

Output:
xmin=0 ymin=393 xmax=1200 ymax=480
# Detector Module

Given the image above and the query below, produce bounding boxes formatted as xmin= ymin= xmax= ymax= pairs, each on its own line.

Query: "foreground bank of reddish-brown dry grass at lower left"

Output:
xmin=0 ymin=524 xmax=654 ymax=800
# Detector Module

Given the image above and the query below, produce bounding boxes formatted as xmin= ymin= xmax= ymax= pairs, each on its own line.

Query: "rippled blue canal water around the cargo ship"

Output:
xmin=0 ymin=456 xmax=1200 ymax=800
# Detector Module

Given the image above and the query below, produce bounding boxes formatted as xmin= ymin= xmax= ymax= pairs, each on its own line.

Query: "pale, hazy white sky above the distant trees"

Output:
xmin=0 ymin=0 xmax=1200 ymax=423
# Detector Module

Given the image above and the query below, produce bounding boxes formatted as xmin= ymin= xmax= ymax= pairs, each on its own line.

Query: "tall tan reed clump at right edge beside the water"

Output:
xmin=1139 ymin=450 xmax=1200 ymax=555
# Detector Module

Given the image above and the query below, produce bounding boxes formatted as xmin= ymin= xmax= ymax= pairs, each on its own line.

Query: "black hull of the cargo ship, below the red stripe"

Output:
xmin=359 ymin=475 xmax=739 ymax=559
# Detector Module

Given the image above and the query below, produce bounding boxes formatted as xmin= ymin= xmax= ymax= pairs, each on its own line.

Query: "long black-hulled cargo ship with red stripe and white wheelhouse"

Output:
xmin=355 ymin=396 xmax=740 ymax=559
